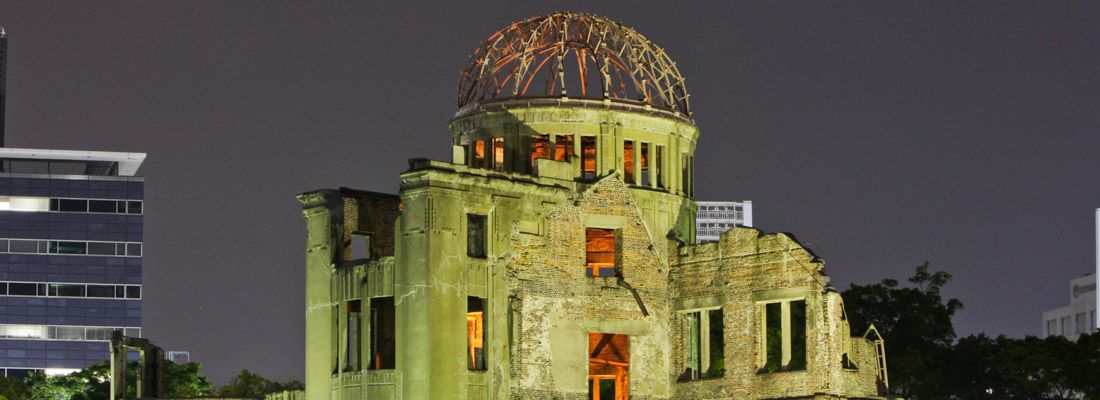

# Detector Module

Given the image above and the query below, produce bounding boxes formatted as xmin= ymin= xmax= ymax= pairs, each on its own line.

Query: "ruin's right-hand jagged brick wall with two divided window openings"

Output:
xmin=670 ymin=227 xmax=879 ymax=399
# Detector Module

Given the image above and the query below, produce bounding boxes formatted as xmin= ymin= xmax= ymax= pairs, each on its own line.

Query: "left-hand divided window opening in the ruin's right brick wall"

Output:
xmin=680 ymin=308 xmax=726 ymax=380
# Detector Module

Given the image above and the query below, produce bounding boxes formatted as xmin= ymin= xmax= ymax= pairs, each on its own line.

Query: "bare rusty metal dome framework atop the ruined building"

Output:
xmin=458 ymin=12 xmax=691 ymax=119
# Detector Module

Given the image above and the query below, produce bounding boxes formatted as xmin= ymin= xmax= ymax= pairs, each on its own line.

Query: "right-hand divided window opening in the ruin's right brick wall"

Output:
xmin=759 ymin=300 xmax=806 ymax=373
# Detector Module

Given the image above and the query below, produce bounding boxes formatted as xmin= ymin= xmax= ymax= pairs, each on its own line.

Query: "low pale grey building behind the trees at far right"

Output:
xmin=1041 ymin=274 xmax=1097 ymax=341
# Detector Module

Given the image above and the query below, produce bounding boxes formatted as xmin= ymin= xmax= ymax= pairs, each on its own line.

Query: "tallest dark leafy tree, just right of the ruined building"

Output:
xmin=842 ymin=262 xmax=963 ymax=399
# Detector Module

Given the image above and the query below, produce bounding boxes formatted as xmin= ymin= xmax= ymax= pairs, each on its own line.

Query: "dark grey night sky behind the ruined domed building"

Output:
xmin=0 ymin=0 xmax=1100 ymax=382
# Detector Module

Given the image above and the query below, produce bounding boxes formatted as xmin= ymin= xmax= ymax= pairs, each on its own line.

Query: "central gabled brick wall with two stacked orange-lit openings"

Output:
xmin=505 ymin=176 xmax=669 ymax=399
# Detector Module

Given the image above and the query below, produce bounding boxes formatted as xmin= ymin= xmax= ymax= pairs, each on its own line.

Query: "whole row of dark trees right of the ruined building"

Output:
xmin=842 ymin=263 xmax=1100 ymax=400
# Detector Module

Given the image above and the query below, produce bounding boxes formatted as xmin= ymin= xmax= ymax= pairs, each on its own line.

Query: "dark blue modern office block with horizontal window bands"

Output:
xmin=0 ymin=148 xmax=145 ymax=377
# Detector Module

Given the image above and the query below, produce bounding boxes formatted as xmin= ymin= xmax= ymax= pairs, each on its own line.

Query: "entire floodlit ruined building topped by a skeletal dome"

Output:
xmin=298 ymin=13 xmax=886 ymax=400
